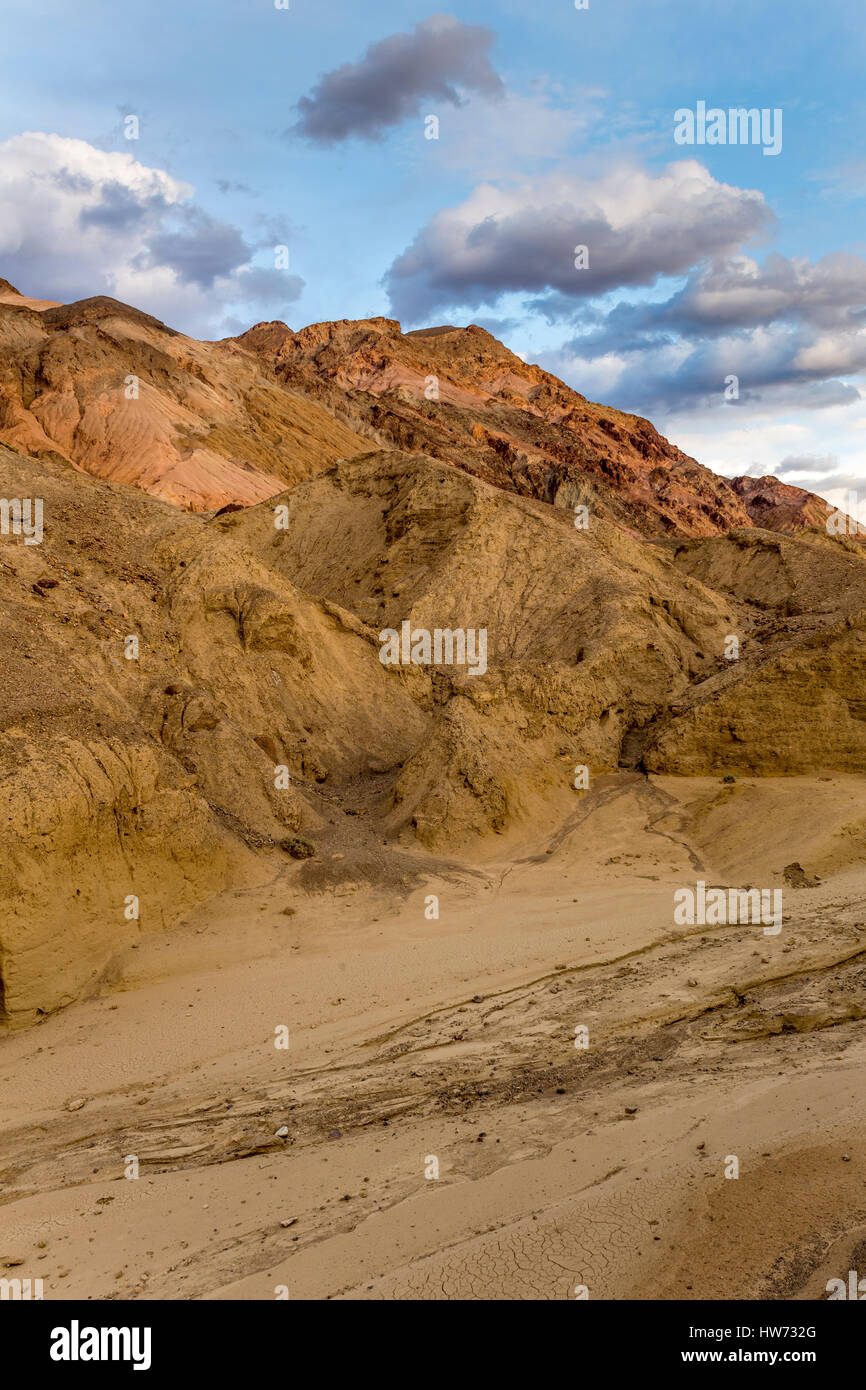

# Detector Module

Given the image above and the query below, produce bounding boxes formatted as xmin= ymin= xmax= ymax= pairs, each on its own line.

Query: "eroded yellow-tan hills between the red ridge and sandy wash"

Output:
xmin=0 ymin=449 xmax=866 ymax=1022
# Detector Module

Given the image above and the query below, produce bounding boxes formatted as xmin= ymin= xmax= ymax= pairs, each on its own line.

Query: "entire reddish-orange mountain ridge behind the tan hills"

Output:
xmin=0 ymin=281 xmax=830 ymax=537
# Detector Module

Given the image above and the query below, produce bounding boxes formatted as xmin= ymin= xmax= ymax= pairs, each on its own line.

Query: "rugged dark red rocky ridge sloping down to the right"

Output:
xmin=238 ymin=318 xmax=824 ymax=535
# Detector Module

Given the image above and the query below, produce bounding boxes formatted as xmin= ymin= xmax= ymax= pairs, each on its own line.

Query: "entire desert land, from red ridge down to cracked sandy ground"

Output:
xmin=0 ymin=281 xmax=866 ymax=1301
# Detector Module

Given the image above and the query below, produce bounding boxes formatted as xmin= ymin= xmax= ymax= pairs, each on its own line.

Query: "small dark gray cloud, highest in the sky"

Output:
xmin=292 ymin=14 xmax=505 ymax=145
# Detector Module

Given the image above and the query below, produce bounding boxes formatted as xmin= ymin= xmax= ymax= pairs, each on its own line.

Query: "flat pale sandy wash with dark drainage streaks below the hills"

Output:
xmin=0 ymin=773 xmax=866 ymax=1300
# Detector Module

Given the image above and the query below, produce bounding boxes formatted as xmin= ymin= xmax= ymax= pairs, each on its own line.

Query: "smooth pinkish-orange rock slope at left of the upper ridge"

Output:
xmin=0 ymin=290 xmax=364 ymax=512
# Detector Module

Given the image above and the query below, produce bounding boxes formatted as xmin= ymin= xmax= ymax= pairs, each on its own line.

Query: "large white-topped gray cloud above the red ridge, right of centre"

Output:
xmin=385 ymin=160 xmax=773 ymax=321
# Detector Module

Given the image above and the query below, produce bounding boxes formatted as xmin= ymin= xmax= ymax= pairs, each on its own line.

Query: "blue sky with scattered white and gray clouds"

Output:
xmin=0 ymin=0 xmax=866 ymax=520
